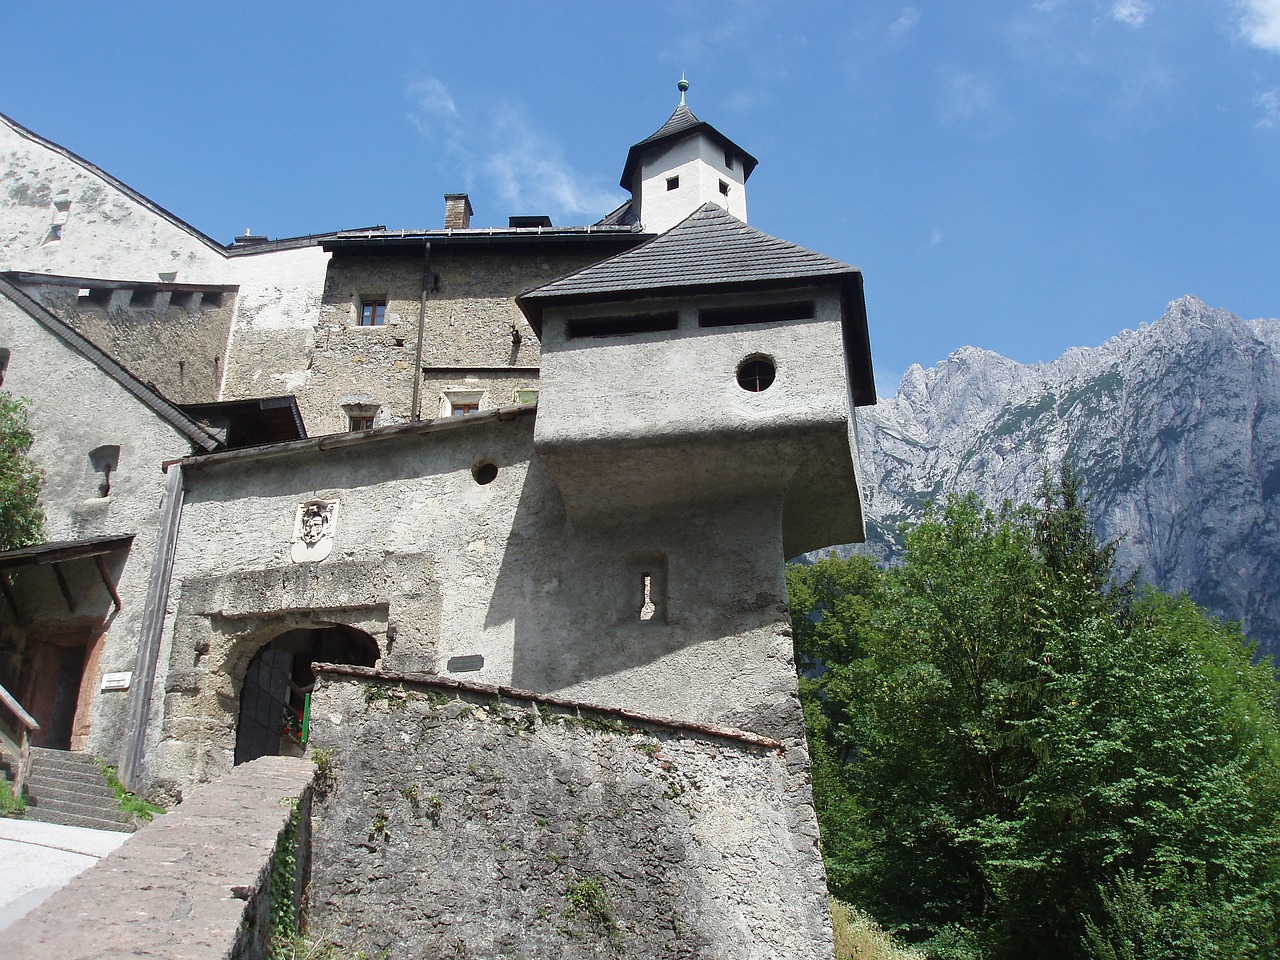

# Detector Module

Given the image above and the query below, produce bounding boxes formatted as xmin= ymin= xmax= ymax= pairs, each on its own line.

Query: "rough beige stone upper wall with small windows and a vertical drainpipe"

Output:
xmin=248 ymin=247 xmax=607 ymax=435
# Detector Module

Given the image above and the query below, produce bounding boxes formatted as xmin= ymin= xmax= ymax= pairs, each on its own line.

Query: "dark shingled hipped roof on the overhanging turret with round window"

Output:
xmin=516 ymin=202 xmax=876 ymax=406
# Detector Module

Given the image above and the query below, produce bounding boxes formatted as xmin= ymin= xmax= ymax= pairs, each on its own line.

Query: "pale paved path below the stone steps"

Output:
xmin=0 ymin=817 xmax=131 ymax=931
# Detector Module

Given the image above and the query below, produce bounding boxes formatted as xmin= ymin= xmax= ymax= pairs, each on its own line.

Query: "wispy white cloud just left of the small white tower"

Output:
xmin=404 ymin=77 xmax=622 ymax=223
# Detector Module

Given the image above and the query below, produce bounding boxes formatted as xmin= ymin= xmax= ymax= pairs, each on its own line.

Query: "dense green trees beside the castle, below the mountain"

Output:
xmin=788 ymin=470 xmax=1280 ymax=960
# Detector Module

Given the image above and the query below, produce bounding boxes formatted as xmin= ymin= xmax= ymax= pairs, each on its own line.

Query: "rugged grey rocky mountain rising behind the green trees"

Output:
xmin=859 ymin=297 xmax=1280 ymax=653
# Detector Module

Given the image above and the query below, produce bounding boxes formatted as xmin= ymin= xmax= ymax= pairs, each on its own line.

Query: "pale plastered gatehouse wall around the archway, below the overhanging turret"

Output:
xmin=148 ymin=413 xmax=800 ymax=786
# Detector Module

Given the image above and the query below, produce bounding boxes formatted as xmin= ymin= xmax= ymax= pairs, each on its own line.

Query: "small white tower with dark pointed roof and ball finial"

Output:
xmin=621 ymin=78 xmax=756 ymax=233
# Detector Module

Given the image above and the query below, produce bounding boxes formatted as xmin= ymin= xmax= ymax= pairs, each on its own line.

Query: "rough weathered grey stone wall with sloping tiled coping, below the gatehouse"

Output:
xmin=311 ymin=668 xmax=832 ymax=960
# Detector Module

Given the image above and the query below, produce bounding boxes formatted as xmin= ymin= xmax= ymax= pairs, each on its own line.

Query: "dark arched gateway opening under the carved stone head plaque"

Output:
xmin=234 ymin=625 xmax=379 ymax=764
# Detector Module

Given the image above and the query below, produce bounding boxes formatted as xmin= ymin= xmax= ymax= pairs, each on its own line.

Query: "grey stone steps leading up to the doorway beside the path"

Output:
xmin=27 ymin=746 xmax=134 ymax=832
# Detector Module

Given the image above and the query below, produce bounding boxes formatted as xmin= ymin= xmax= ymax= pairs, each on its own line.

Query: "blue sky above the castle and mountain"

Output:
xmin=0 ymin=0 xmax=1280 ymax=396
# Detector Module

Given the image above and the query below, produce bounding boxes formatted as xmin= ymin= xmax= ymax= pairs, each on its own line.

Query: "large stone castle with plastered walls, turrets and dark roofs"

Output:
xmin=0 ymin=86 xmax=874 ymax=957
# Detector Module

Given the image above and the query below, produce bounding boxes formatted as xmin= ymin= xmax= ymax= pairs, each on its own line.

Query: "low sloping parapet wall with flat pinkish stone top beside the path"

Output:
xmin=4 ymin=756 xmax=315 ymax=960
